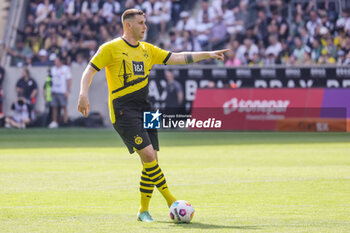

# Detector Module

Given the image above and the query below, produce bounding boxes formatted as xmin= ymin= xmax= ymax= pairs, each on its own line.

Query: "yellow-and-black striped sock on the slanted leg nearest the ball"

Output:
xmin=143 ymin=160 xmax=176 ymax=207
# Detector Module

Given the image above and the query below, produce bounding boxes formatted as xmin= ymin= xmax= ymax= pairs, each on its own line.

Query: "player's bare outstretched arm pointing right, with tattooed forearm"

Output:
xmin=166 ymin=49 xmax=229 ymax=65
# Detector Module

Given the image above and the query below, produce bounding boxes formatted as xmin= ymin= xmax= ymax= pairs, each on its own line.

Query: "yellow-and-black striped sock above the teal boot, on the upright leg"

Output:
xmin=139 ymin=168 xmax=154 ymax=213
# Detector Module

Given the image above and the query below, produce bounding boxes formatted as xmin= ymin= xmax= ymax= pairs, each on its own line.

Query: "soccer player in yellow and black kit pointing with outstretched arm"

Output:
xmin=78 ymin=9 xmax=228 ymax=222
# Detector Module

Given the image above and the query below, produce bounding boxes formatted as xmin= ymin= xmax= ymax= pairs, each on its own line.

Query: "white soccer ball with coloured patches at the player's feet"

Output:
xmin=169 ymin=200 xmax=194 ymax=222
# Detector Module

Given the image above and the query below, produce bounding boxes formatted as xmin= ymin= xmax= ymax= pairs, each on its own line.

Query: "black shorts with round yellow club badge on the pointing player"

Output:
xmin=113 ymin=100 xmax=159 ymax=154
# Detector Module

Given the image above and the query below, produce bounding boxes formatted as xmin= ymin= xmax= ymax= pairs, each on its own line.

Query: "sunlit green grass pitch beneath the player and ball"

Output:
xmin=0 ymin=129 xmax=350 ymax=233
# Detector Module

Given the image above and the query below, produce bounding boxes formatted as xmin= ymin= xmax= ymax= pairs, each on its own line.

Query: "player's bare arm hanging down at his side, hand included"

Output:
xmin=78 ymin=65 xmax=96 ymax=117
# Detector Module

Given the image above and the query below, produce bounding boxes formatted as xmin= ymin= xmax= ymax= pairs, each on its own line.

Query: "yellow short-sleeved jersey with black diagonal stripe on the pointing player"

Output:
xmin=89 ymin=37 xmax=171 ymax=124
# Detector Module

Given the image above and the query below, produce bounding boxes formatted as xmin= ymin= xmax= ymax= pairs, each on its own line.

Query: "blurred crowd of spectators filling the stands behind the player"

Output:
xmin=7 ymin=0 xmax=350 ymax=66
